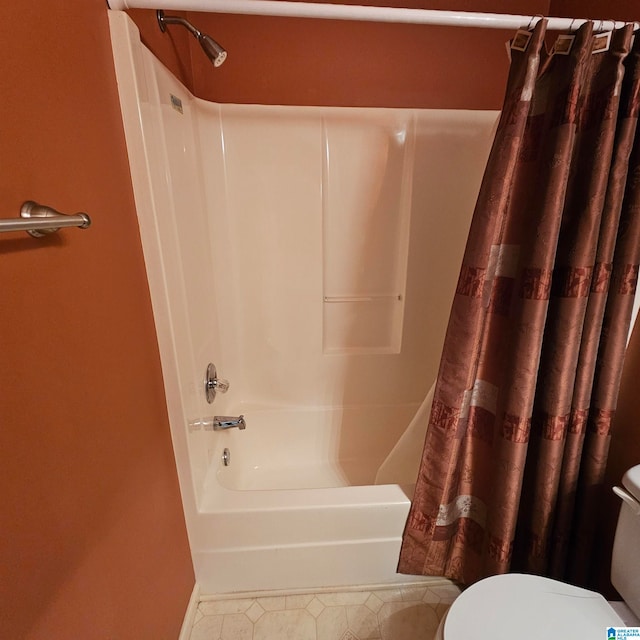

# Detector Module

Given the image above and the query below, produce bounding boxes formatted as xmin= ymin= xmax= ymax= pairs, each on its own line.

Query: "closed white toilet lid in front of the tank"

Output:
xmin=442 ymin=573 xmax=624 ymax=640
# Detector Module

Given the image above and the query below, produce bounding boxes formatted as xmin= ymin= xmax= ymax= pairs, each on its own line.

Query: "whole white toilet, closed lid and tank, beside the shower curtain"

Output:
xmin=436 ymin=465 xmax=640 ymax=640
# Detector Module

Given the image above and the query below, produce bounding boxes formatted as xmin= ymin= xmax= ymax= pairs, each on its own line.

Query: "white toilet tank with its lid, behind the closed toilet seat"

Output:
xmin=611 ymin=465 xmax=640 ymax=617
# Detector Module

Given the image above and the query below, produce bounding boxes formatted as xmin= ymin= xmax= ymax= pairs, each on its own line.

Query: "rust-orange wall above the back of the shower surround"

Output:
xmin=132 ymin=0 xmax=549 ymax=109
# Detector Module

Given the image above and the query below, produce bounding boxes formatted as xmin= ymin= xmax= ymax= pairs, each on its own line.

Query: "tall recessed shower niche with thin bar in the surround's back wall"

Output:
xmin=322 ymin=112 xmax=415 ymax=354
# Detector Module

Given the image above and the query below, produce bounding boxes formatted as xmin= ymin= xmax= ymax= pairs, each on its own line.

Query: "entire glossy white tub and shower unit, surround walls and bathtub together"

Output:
xmin=109 ymin=11 xmax=497 ymax=596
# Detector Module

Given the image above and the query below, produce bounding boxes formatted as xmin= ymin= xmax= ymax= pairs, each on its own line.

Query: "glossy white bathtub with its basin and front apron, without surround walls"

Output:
xmin=195 ymin=405 xmax=424 ymax=593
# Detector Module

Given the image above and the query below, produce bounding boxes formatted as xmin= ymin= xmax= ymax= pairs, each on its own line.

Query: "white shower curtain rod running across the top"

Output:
xmin=109 ymin=0 xmax=640 ymax=31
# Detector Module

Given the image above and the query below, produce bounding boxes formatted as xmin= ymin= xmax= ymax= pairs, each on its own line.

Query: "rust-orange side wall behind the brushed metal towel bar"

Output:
xmin=0 ymin=0 xmax=194 ymax=640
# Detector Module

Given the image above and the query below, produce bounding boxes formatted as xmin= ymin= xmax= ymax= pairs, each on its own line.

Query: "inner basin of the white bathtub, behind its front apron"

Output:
xmin=207 ymin=404 xmax=418 ymax=490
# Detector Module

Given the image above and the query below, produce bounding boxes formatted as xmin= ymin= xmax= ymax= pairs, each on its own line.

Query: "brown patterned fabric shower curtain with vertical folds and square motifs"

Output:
xmin=398 ymin=21 xmax=640 ymax=584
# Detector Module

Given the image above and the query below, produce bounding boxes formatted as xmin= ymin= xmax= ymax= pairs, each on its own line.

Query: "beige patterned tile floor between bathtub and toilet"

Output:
xmin=191 ymin=585 xmax=459 ymax=640
